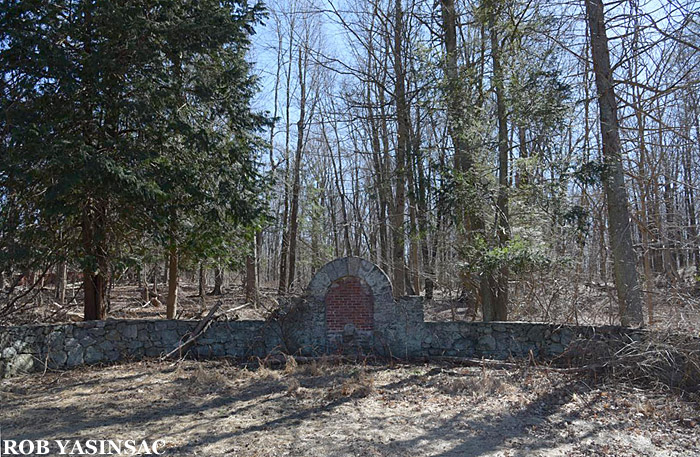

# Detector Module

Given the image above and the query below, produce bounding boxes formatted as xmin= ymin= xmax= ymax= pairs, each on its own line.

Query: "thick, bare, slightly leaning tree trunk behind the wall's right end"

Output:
xmin=584 ymin=0 xmax=644 ymax=326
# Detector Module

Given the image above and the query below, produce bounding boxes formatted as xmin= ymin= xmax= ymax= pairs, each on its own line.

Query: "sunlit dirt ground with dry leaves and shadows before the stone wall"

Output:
xmin=0 ymin=361 xmax=700 ymax=457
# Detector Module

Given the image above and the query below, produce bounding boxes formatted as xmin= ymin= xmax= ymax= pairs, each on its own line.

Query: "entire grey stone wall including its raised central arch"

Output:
xmin=0 ymin=257 xmax=639 ymax=378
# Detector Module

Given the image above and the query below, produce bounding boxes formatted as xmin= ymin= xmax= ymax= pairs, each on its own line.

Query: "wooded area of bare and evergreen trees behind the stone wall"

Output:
xmin=0 ymin=0 xmax=700 ymax=325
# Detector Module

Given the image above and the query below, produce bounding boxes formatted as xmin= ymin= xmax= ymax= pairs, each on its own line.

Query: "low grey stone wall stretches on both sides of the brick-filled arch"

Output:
xmin=0 ymin=314 xmax=639 ymax=378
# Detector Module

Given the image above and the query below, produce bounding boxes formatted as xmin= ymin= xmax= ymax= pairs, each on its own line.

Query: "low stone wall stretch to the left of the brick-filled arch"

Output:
xmin=0 ymin=320 xmax=283 ymax=378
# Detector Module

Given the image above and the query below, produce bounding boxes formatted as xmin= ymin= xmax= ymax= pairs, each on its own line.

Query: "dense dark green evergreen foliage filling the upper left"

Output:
xmin=0 ymin=0 xmax=266 ymax=282
